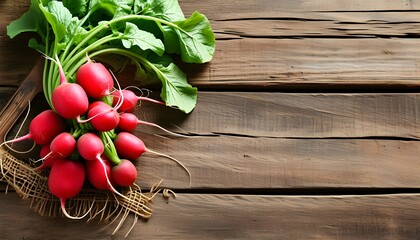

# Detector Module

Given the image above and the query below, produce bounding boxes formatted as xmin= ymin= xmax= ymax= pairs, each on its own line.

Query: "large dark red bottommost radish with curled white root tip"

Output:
xmin=48 ymin=159 xmax=89 ymax=219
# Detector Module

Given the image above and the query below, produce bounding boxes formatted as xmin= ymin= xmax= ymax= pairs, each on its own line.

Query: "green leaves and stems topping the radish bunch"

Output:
xmin=7 ymin=0 xmax=215 ymax=113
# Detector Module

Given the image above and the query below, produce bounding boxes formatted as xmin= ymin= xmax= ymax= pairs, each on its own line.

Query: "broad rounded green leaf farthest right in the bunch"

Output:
xmin=162 ymin=12 xmax=216 ymax=63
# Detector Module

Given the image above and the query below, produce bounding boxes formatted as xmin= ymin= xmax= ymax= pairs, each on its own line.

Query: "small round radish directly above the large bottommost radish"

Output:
xmin=47 ymin=132 xmax=76 ymax=158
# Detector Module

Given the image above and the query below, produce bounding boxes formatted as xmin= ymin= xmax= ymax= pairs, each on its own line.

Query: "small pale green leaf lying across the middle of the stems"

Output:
xmin=122 ymin=22 xmax=165 ymax=56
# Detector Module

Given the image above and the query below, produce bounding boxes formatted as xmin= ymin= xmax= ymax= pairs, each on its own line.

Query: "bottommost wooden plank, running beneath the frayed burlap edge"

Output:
xmin=0 ymin=194 xmax=420 ymax=240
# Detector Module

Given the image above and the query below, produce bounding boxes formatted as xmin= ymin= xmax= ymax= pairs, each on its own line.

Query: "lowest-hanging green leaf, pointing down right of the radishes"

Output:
xmin=153 ymin=63 xmax=197 ymax=113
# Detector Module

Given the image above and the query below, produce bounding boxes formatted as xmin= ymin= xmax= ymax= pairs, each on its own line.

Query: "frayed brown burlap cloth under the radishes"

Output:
xmin=0 ymin=147 xmax=158 ymax=235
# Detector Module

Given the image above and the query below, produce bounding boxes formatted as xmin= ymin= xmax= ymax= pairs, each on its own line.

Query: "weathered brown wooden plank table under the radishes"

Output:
xmin=0 ymin=0 xmax=420 ymax=239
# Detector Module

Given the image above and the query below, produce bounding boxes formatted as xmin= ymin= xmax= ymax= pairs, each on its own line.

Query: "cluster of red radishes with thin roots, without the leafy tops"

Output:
xmin=5 ymin=55 xmax=189 ymax=218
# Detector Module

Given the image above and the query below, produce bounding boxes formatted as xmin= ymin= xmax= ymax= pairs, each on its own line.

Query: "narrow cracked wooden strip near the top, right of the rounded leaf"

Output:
xmin=212 ymin=11 xmax=420 ymax=39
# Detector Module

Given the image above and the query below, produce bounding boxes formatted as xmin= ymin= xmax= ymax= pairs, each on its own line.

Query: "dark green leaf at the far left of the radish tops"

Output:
xmin=7 ymin=0 xmax=46 ymax=38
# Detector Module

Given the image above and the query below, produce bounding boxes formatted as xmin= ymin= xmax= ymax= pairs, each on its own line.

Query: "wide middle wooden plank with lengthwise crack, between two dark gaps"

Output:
xmin=2 ymin=92 xmax=420 ymax=189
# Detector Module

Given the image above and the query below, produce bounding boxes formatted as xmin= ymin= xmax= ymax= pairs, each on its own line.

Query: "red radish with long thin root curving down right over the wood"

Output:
xmin=114 ymin=132 xmax=191 ymax=185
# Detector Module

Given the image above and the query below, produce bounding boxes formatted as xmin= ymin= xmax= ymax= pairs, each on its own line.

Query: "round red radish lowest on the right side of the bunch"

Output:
xmin=111 ymin=159 xmax=137 ymax=187
